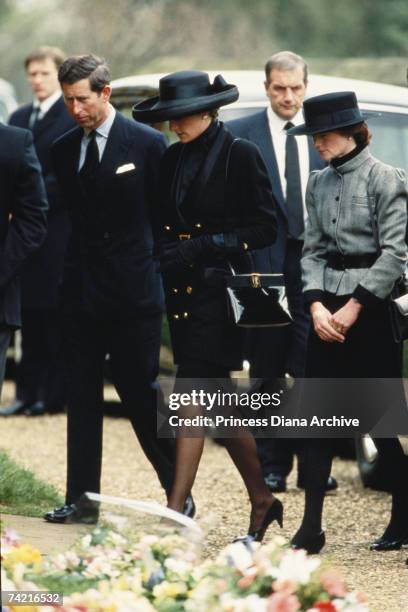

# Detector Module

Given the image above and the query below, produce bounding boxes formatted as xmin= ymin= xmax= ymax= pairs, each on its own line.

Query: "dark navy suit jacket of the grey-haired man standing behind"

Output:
xmin=226 ymin=109 xmax=324 ymax=272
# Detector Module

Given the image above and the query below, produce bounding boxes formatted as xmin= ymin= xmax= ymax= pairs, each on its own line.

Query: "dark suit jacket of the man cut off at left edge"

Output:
xmin=0 ymin=124 xmax=48 ymax=328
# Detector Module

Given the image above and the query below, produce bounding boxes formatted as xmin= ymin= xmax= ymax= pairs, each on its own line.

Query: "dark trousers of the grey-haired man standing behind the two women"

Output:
xmin=249 ymin=240 xmax=310 ymax=477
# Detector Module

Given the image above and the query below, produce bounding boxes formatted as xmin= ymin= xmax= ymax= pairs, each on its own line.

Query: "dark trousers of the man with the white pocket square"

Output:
xmin=66 ymin=314 xmax=174 ymax=503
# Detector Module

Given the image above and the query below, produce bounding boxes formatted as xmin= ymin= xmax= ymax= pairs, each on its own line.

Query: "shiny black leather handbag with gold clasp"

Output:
xmin=226 ymin=271 xmax=292 ymax=327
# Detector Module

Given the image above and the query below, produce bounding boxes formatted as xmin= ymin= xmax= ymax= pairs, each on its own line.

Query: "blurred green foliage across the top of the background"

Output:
xmin=0 ymin=0 xmax=408 ymax=99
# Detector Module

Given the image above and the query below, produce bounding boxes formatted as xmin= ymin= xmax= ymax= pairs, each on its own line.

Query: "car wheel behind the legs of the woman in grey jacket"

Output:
xmin=356 ymin=435 xmax=390 ymax=492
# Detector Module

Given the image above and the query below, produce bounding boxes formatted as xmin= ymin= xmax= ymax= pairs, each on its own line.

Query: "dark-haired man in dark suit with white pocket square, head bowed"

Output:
xmin=45 ymin=55 xmax=178 ymax=523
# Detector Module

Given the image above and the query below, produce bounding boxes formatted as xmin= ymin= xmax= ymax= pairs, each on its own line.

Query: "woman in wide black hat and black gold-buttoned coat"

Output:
xmin=133 ymin=71 xmax=283 ymax=540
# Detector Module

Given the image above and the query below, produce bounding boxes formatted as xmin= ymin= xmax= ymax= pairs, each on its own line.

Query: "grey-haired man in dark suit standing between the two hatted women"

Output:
xmin=227 ymin=51 xmax=337 ymax=492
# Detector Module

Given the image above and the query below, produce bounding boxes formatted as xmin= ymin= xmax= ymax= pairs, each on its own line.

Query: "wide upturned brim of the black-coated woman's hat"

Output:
xmin=132 ymin=85 xmax=239 ymax=123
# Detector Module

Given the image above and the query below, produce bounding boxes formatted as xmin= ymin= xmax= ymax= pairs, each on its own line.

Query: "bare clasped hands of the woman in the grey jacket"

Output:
xmin=310 ymin=298 xmax=362 ymax=343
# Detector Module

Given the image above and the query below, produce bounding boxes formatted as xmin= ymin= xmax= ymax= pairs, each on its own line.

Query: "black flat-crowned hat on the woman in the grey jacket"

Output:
xmin=287 ymin=91 xmax=378 ymax=136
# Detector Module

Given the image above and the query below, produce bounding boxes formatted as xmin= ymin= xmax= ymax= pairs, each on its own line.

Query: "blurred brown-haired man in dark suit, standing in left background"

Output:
xmin=5 ymin=47 xmax=75 ymax=416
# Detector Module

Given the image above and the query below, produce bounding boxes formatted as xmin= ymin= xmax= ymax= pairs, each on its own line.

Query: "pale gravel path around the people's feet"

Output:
xmin=0 ymin=394 xmax=408 ymax=612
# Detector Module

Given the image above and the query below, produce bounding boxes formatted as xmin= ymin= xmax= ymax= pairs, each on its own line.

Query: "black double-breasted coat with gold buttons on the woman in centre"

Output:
xmin=155 ymin=126 xmax=276 ymax=369
